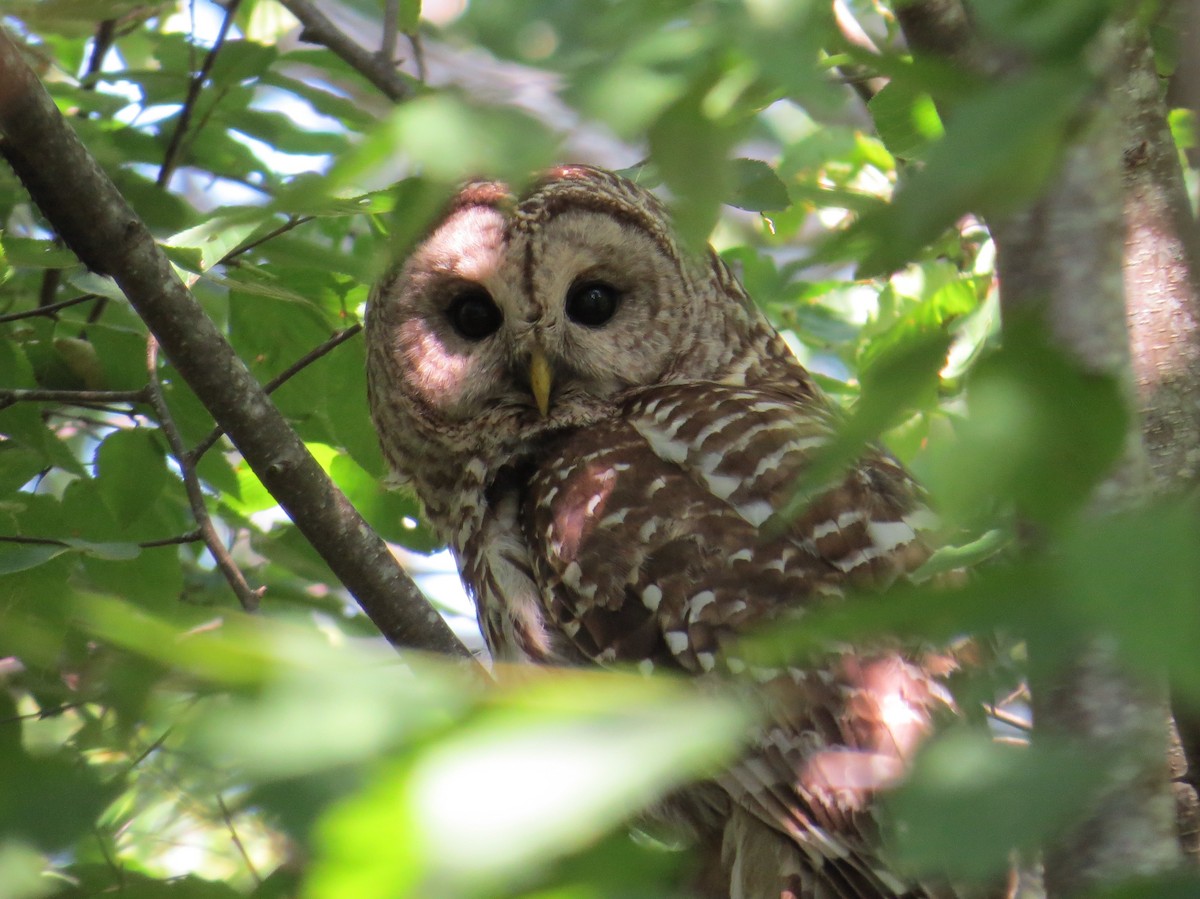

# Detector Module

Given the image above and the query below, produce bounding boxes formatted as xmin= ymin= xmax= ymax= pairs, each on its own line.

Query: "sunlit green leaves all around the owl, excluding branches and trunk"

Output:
xmin=0 ymin=0 xmax=1200 ymax=899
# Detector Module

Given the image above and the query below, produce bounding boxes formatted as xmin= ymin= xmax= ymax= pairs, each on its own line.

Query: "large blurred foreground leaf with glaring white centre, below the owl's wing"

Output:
xmin=308 ymin=672 xmax=748 ymax=899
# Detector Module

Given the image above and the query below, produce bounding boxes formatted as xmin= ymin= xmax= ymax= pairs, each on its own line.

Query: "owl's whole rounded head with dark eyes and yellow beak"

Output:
xmin=367 ymin=166 xmax=757 ymax=487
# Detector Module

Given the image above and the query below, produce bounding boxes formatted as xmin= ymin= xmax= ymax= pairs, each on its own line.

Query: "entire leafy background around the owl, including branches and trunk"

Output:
xmin=0 ymin=0 xmax=1200 ymax=899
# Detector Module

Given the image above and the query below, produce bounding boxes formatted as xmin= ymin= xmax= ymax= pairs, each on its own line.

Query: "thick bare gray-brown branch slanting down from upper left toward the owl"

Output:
xmin=0 ymin=22 xmax=469 ymax=658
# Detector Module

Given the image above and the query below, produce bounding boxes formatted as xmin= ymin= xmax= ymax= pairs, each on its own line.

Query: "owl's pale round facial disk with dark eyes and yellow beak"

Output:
xmin=392 ymin=200 xmax=686 ymax=432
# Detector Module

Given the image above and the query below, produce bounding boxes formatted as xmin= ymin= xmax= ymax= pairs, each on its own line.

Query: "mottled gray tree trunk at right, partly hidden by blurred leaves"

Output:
xmin=898 ymin=0 xmax=1185 ymax=897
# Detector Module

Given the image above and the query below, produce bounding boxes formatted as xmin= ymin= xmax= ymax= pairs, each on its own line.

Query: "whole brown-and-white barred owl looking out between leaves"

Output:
xmin=367 ymin=166 xmax=947 ymax=899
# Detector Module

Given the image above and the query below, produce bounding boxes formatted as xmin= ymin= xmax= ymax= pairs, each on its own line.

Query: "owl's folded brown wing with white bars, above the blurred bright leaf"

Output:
xmin=524 ymin=383 xmax=930 ymax=673
